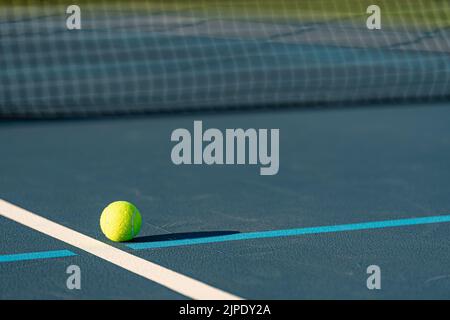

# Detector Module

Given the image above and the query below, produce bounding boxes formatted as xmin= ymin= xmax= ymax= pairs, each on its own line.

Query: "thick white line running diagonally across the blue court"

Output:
xmin=0 ymin=199 xmax=242 ymax=300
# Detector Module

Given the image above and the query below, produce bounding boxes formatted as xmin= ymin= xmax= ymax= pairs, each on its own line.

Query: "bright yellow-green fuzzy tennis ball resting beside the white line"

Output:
xmin=100 ymin=201 xmax=142 ymax=242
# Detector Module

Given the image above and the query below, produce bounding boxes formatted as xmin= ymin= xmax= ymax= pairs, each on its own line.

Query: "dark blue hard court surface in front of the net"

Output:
xmin=0 ymin=105 xmax=450 ymax=299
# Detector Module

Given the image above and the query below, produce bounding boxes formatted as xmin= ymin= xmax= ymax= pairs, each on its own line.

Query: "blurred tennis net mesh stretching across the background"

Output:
xmin=0 ymin=0 xmax=450 ymax=117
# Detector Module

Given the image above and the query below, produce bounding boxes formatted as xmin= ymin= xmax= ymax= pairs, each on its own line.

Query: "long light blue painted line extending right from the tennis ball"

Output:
xmin=126 ymin=215 xmax=450 ymax=250
